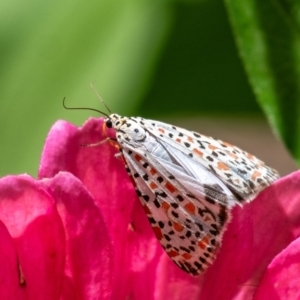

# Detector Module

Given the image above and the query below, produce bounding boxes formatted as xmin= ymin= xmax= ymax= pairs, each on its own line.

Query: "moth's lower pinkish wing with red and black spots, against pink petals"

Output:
xmin=122 ymin=145 xmax=229 ymax=275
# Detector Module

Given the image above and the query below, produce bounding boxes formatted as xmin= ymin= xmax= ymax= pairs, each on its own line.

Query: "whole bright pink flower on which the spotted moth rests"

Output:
xmin=0 ymin=119 xmax=300 ymax=300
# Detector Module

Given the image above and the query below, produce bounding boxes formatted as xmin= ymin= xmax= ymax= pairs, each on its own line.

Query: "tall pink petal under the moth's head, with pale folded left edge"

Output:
xmin=39 ymin=119 xmax=172 ymax=299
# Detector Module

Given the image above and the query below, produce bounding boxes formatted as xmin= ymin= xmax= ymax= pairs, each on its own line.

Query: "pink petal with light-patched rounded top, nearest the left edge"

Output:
xmin=0 ymin=175 xmax=65 ymax=300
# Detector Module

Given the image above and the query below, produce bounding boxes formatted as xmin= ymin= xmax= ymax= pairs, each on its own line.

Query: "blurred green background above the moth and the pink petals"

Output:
xmin=0 ymin=0 xmax=300 ymax=176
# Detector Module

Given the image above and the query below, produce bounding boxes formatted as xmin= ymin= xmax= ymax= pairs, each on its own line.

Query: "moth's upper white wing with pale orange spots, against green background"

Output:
xmin=136 ymin=118 xmax=278 ymax=201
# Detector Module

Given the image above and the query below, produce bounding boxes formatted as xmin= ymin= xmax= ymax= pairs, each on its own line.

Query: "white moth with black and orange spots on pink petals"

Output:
xmin=105 ymin=114 xmax=278 ymax=275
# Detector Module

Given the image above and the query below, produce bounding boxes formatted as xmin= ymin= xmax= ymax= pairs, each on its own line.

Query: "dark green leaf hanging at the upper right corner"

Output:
xmin=225 ymin=0 xmax=300 ymax=164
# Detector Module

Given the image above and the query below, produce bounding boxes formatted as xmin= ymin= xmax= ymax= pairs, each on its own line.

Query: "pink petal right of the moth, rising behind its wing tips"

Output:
xmin=200 ymin=172 xmax=300 ymax=300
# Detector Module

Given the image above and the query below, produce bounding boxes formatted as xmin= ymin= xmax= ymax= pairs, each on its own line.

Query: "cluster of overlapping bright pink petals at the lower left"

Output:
xmin=0 ymin=172 xmax=114 ymax=300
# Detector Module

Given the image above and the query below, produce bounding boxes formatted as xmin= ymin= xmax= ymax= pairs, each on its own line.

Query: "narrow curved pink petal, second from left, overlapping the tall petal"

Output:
xmin=41 ymin=172 xmax=113 ymax=300
